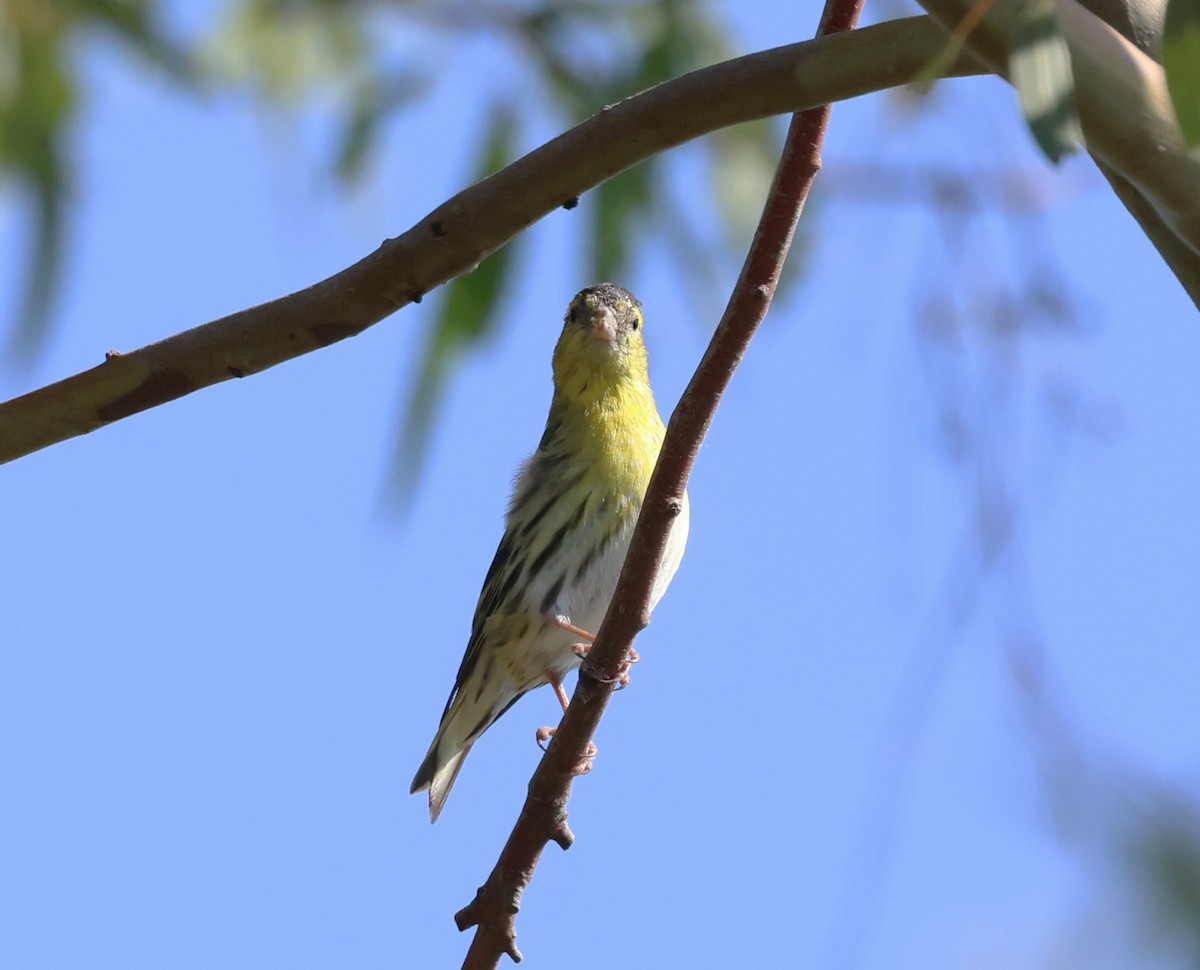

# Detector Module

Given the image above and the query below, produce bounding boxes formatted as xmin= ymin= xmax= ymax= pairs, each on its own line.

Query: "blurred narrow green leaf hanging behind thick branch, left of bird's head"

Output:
xmin=392 ymin=106 xmax=516 ymax=502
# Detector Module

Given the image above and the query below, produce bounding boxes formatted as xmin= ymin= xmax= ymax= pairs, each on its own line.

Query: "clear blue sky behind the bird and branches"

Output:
xmin=0 ymin=7 xmax=1200 ymax=969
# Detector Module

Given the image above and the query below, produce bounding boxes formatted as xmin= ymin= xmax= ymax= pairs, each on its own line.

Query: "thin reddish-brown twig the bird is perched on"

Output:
xmin=455 ymin=0 xmax=863 ymax=970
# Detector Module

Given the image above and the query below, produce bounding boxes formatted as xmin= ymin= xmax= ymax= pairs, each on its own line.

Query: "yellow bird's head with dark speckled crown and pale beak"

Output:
xmin=554 ymin=283 xmax=649 ymax=395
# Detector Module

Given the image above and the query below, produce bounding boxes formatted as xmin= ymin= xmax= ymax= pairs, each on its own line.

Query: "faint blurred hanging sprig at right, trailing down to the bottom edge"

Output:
xmin=821 ymin=149 xmax=1114 ymax=968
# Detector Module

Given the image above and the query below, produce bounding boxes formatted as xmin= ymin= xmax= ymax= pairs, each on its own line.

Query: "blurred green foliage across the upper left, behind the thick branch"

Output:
xmin=0 ymin=0 xmax=776 ymax=483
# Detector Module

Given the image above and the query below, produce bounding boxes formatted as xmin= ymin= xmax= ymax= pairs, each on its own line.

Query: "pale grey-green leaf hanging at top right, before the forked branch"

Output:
xmin=1008 ymin=0 xmax=1084 ymax=164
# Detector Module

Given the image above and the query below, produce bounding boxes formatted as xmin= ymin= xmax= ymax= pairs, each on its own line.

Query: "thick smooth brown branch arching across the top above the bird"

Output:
xmin=0 ymin=18 xmax=982 ymax=462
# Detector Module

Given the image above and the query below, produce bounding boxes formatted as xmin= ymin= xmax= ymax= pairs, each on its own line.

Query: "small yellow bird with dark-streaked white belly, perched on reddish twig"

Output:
xmin=410 ymin=283 xmax=690 ymax=822
